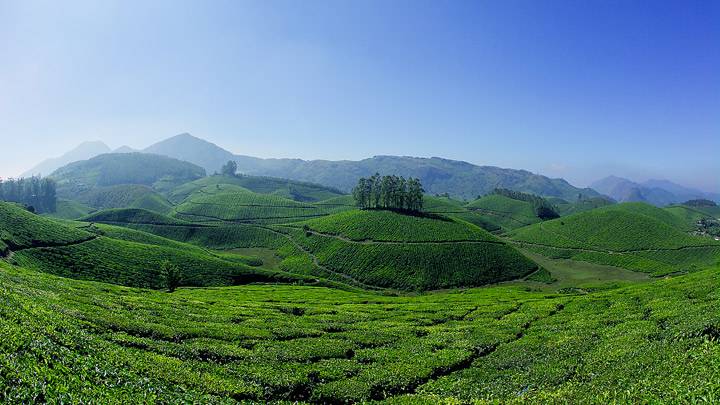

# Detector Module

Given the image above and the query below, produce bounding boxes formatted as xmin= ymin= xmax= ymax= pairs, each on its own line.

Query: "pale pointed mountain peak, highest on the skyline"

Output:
xmin=142 ymin=133 xmax=235 ymax=173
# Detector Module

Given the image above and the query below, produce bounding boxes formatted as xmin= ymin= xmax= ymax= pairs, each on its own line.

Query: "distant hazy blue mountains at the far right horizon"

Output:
xmin=590 ymin=176 xmax=720 ymax=207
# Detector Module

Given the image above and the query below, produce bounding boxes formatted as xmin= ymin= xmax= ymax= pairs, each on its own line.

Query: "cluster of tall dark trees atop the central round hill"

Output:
xmin=353 ymin=173 xmax=425 ymax=212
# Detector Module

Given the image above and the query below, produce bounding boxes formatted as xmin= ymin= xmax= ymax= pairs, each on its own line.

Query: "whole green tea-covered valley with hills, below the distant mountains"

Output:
xmin=0 ymin=147 xmax=720 ymax=404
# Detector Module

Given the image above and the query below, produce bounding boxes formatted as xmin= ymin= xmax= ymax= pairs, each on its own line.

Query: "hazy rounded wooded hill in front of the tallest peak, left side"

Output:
xmin=51 ymin=153 xmax=205 ymax=195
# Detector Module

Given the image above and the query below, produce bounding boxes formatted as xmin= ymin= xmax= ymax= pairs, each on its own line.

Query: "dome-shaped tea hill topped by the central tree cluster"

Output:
xmin=277 ymin=210 xmax=538 ymax=290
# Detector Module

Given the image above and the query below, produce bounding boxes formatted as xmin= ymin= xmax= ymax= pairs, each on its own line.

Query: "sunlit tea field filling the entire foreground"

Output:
xmin=0 ymin=261 xmax=720 ymax=404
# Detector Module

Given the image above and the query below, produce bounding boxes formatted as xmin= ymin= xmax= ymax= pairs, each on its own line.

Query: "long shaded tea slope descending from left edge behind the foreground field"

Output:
xmin=0 ymin=202 xmax=333 ymax=288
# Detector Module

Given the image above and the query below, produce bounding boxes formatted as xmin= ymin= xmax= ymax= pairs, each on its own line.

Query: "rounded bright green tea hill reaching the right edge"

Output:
xmin=509 ymin=207 xmax=720 ymax=276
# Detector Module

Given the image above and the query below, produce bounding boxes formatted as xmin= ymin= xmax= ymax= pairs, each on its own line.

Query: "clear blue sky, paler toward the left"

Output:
xmin=0 ymin=0 xmax=720 ymax=192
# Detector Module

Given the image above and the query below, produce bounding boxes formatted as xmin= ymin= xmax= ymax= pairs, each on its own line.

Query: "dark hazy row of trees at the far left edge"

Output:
xmin=0 ymin=176 xmax=56 ymax=212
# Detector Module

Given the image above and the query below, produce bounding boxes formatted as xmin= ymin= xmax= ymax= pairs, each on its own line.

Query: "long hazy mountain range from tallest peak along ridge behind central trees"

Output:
xmin=143 ymin=134 xmax=600 ymax=201
